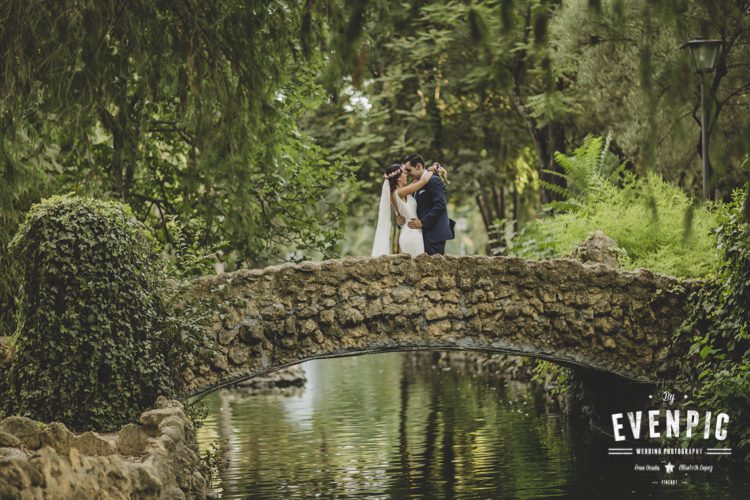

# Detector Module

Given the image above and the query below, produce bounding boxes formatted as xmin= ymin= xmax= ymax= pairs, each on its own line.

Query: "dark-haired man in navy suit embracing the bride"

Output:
xmin=401 ymin=154 xmax=455 ymax=255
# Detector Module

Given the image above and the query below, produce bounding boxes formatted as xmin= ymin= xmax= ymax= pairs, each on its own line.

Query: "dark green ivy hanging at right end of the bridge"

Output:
xmin=675 ymin=190 xmax=750 ymax=460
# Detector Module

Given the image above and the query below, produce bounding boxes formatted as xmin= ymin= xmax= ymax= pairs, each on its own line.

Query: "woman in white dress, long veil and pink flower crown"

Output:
xmin=372 ymin=163 xmax=444 ymax=257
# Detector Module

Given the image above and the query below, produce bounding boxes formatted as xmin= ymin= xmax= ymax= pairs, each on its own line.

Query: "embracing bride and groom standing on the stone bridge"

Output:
xmin=372 ymin=154 xmax=455 ymax=257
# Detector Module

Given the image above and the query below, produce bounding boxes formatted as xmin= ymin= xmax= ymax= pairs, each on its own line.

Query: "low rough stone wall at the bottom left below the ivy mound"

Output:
xmin=0 ymin=398 xmax=206 ymax=500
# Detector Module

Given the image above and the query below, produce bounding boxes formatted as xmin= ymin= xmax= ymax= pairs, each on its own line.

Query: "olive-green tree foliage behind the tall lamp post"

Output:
xmin=550 ymin=0 xmax=750 ymax=193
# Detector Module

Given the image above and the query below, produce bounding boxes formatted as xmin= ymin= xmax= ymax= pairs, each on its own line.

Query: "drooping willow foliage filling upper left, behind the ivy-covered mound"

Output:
xmin=0 ymin=0 xmax=363 ymax=335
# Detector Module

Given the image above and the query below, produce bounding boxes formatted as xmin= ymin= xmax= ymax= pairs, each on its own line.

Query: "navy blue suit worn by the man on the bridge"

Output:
xmin=417 ymin=175 xmax=455 ymax=255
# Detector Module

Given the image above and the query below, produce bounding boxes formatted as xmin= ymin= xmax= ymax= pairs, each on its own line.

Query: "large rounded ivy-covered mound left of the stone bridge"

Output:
xmin=5 ymin=196 xmax=187 ymax=430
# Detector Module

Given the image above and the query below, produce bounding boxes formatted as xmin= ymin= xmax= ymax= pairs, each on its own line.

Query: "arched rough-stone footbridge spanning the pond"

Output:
xmin=185 ymin=255 xmax=694 ymax=396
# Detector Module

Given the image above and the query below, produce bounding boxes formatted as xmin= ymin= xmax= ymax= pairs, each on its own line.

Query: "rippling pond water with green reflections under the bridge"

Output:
xmin=198 ymin=354 xmax=750 ymax=500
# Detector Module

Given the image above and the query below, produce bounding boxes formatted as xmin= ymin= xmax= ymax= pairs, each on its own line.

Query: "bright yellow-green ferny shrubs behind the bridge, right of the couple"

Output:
xmin=509 ymin=138 xmax=719 ymax=278
